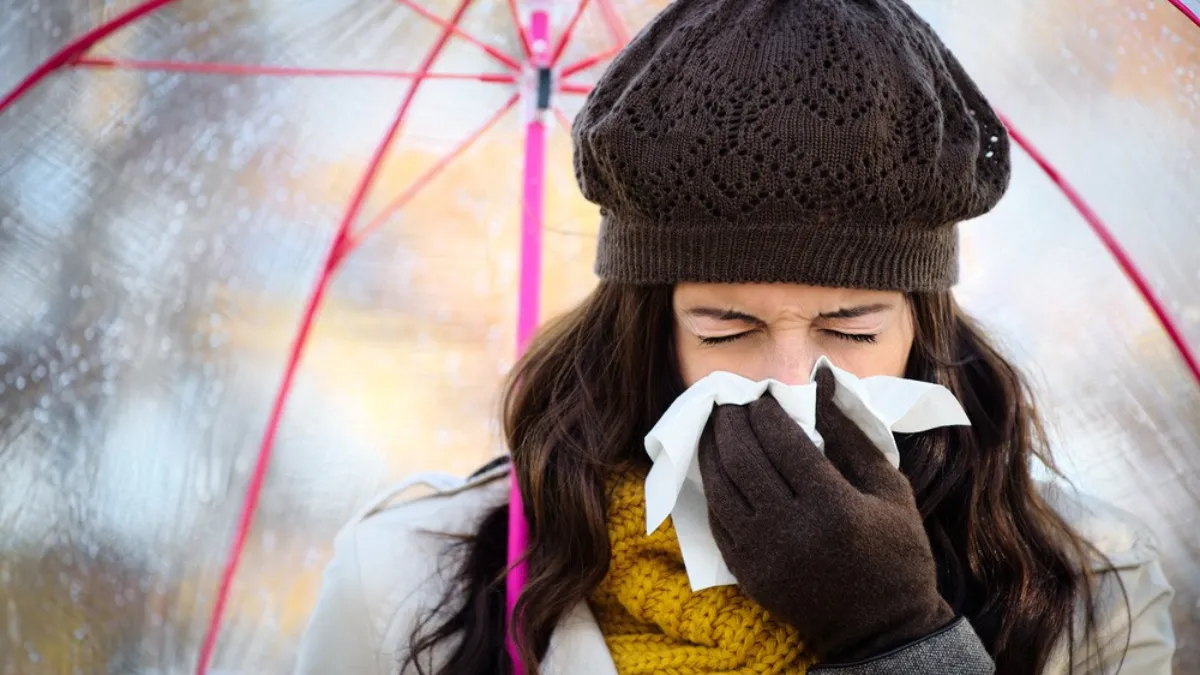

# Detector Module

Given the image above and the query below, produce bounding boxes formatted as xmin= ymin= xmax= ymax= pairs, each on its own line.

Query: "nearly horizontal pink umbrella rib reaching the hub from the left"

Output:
xmin=71 ymin=56 xmax=516 ymax=84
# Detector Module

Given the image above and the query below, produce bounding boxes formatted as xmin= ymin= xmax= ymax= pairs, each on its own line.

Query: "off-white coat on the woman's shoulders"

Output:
xmin=295 ymin=467 xmax=1175 ymax=675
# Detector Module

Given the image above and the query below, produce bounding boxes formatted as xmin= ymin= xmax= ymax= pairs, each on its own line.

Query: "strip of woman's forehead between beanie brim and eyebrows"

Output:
xmin=674 ymin=283 xmax=904 ymax=313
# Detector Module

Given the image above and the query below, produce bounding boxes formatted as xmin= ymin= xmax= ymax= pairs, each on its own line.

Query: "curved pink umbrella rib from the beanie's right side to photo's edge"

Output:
xmin=1004 ymin=119 xmax=1200 ymax=384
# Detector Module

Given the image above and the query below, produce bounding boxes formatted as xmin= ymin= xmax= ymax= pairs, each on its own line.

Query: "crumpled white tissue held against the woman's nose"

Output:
xmin=646 ymin=357 xmax=971 ymax=591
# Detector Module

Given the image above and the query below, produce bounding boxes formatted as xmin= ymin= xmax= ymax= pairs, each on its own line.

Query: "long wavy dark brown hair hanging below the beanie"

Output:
xmin=406 ymin=282 xmax=1113 ymax=675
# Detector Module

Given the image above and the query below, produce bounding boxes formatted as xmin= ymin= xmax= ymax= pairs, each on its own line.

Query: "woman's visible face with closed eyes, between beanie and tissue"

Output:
xmin=673 ymin=283 xmax=913 ymax=387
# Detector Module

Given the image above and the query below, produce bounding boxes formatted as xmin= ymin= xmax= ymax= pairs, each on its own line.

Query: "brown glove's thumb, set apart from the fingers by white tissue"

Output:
xmin=816 ymin=368 xmax=912 ymax=501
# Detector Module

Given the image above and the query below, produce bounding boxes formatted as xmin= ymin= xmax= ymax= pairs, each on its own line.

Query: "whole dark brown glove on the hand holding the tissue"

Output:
xmin=700 ymin=369 xmax=954 ymax=663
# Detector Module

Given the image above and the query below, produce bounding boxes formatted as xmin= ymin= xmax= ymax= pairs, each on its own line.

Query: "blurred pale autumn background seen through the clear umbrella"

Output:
xmin=0 ymin=0 xmax=1200 ymax=675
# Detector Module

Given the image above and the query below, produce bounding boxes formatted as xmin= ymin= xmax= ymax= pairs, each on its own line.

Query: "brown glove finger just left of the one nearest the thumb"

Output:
xmin=713 ymin=398 xmax=792 ymax=513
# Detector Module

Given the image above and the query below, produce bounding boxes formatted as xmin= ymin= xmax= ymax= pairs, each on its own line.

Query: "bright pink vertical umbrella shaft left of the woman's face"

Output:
xmin=505 ymin=8 xmax=550 ymax=675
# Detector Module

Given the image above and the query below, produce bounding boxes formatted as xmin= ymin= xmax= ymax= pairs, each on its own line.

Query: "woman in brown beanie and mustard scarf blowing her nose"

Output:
xmin=298 ymin=0 xmax=1172 ymax=675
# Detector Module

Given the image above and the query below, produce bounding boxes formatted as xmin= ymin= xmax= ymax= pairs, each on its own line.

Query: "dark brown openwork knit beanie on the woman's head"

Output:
xmin=575 ymin=0 xmax=1009 ymax=291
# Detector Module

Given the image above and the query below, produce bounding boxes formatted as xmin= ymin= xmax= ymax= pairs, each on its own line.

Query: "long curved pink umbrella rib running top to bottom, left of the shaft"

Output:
xmin=189 ymin=0 xmax=472 ymax=675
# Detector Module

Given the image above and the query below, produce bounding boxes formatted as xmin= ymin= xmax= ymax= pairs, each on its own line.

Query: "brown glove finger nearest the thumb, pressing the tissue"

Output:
xmin=749 ymin=394 xmax=853 ymax=502
